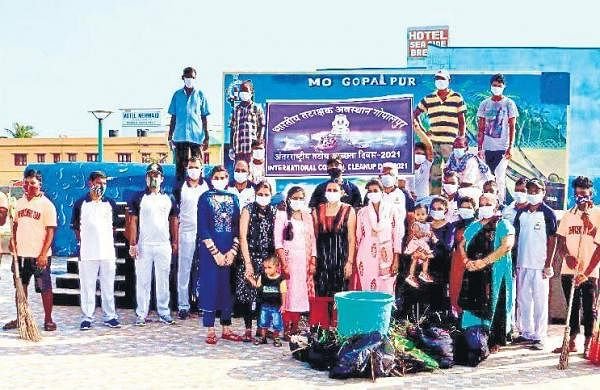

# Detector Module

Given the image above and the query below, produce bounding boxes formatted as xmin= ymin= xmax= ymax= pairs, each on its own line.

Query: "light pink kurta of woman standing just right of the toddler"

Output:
xmin=273 ymin=210 xmax=317 ymax=313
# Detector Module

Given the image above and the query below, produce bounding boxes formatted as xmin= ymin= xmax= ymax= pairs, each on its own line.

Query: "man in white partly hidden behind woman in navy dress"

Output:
xmin=175 ymin=157 xmax=208 ymax=320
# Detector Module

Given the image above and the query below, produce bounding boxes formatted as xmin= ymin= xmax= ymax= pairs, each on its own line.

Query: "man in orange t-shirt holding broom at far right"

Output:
xmin=554 ymin=176 xmax=600 ymax=358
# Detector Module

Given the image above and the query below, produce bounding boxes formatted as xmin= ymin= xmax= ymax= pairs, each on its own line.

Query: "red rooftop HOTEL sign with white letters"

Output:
xmin=406 ymin=26 xmax=449 ymax=66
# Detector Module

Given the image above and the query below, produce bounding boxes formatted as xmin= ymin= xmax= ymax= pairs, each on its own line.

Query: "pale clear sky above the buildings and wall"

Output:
xmin=0 ymin=0 xmax=600 ymax=137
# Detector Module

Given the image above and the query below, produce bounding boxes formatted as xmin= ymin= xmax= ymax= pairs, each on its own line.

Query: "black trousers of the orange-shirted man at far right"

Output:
xmin=561 ymin=275 xmax=598 ymax=337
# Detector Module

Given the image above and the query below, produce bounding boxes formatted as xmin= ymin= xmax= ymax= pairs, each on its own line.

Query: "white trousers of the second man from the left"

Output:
xmin=79 ymin=260 xmax=117 ymax=322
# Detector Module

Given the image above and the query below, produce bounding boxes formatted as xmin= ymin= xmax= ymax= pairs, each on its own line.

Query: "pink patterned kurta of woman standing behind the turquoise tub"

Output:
xmin=356 ymin=201 xmax=404 ymax=295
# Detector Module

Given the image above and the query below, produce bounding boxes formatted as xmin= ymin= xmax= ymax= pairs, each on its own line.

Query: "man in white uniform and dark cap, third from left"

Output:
xmin=128 ymin=163 xmax=179 ymax=326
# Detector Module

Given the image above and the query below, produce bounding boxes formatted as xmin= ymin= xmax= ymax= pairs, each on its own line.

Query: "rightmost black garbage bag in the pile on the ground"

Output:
xmin=454 ymin=326 xmax=490 ymax=367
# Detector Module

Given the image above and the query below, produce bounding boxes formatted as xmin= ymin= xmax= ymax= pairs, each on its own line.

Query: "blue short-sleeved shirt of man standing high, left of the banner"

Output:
xmin=169 ymin=88 xmax=210 ymax=144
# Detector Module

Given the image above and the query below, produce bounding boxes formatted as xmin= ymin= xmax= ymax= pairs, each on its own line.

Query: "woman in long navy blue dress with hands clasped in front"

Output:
xmin=196 ymin=166 xmax=242 ymax=344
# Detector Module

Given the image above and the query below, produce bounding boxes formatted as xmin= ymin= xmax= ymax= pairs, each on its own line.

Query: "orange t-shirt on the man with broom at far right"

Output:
xmin=556 ymin=206 xmax=600 ymax=278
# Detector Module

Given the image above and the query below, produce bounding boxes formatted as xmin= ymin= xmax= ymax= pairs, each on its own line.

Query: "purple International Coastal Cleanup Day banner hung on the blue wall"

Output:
xmin=266 ymin=95 xmax=413 ymax=177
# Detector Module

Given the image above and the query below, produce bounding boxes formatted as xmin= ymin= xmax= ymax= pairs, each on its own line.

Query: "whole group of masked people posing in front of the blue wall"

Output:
xmin=0 ymin=69 xmax=600 ymax=358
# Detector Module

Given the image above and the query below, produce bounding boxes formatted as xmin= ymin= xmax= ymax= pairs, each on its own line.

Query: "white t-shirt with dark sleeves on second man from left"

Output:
xmin=74 ymin=197 xmax=116 ymax=261
